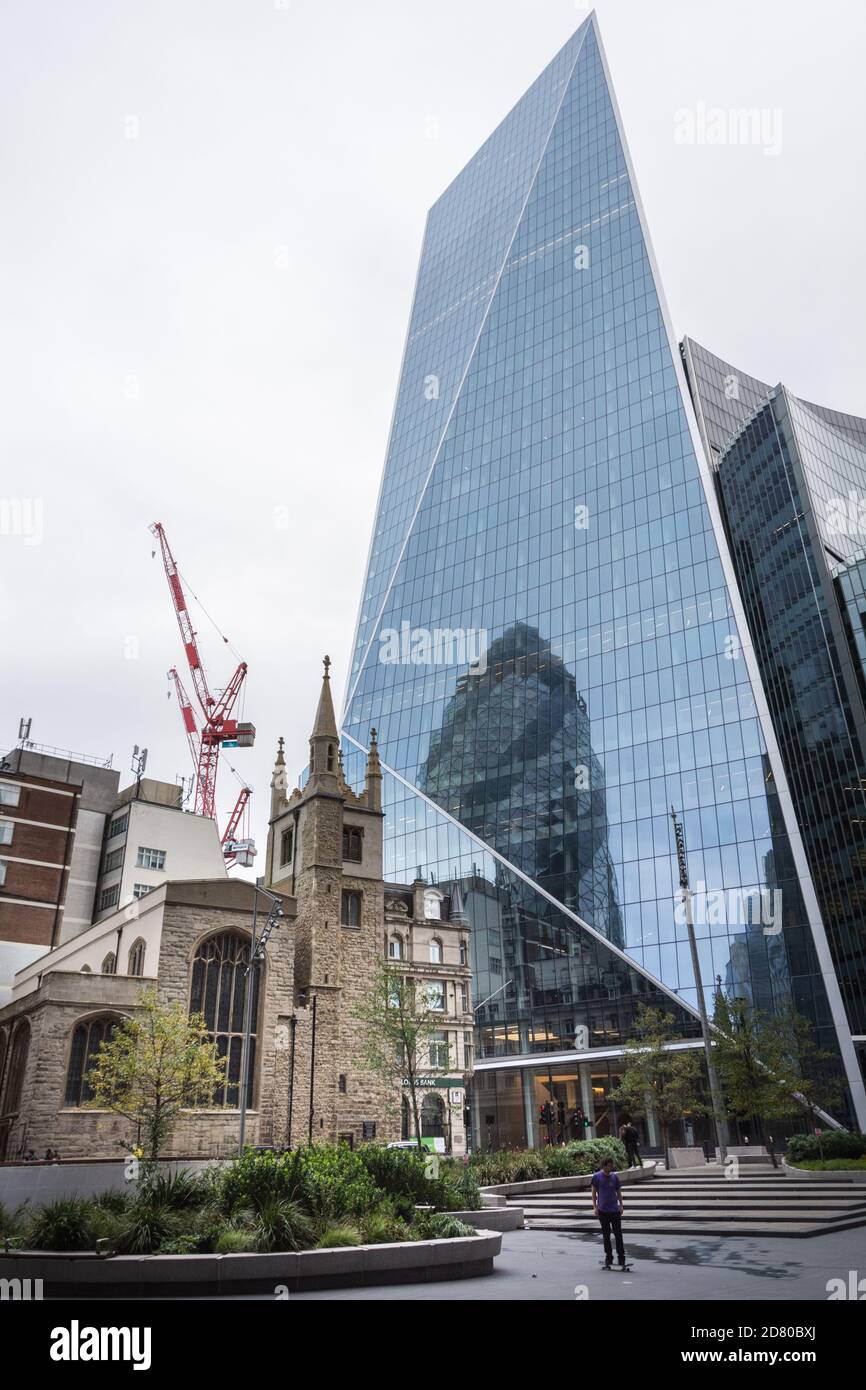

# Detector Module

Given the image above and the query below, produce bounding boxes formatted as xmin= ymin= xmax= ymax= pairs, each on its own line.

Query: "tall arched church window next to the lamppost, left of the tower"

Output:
xmin=189 ymin=931 xmax=260 ymax=1109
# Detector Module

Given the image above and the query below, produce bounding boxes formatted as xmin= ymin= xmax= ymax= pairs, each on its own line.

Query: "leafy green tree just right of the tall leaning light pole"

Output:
xmin=713 ymin=986 xmax=841 ymax=1143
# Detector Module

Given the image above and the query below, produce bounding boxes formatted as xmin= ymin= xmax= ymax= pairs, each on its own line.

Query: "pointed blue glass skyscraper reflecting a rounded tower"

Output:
xmin=342 ymin=17 xmax=866 ymax=1144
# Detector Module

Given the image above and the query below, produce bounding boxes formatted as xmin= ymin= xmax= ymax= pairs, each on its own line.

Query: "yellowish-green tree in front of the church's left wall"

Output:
xmin=88 ymin=990 xmax=225 ymax=1162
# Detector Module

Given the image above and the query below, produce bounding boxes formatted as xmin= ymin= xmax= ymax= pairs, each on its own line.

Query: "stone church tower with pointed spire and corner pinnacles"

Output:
xmin=267 ymin=656 xmax=399 ymax=1144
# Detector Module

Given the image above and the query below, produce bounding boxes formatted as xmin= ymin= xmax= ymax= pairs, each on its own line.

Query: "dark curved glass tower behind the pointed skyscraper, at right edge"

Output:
xmin=683 ymin=339 xmax=866 ymax=1073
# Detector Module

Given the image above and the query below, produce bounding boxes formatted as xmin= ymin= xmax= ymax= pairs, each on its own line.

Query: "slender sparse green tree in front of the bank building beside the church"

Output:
xmin=353 ymin=960 xmax=450 ymax=1150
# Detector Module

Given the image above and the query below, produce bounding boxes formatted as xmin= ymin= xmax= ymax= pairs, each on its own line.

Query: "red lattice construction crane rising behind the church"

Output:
xmin=150 ymin=521 xmax=256 ymax=862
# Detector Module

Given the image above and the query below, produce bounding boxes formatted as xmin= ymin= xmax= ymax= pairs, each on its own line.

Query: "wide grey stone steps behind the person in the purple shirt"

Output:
xmin=509 ymin=1163 xmax=866 ymax=1240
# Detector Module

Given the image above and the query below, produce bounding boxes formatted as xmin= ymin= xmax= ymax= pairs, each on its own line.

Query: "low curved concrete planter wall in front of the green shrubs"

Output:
xmin=0 ymin=1230 xmax=502 ymax=1298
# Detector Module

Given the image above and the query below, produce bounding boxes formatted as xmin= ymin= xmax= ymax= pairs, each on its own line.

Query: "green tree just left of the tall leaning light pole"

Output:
xmin=610 ymin=1008 xmax=709 ymax=1166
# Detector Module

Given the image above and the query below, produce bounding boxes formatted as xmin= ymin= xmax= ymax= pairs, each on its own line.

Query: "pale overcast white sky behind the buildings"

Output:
xmin=0 ymin=0 xmax=866 ymax=865
